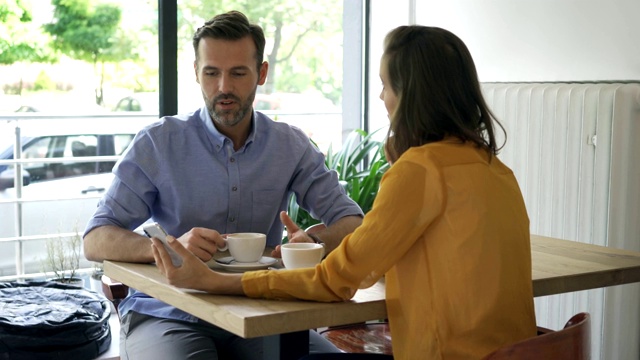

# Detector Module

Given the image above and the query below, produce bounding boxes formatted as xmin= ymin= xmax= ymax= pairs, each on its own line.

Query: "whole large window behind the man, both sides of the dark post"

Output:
xmin=0 ymin=0 xmax=364 ymax=276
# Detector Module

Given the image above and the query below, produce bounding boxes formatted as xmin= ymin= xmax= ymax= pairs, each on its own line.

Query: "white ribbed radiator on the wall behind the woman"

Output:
xmin=482 ymin=83 xmax=640 ymax=360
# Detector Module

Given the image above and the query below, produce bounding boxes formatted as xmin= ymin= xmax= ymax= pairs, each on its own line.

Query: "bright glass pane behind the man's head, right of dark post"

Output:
xmin=178 ymin=0 xmax=343 ymax=150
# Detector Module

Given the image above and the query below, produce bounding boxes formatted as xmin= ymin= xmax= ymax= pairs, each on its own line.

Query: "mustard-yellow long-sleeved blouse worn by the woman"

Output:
xmin=242 ymin=140 xmax=536 ymax=359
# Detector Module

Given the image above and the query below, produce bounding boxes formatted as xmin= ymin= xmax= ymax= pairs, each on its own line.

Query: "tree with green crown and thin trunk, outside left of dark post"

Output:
xmin=44 ymin=0 xmax=138 ymax=105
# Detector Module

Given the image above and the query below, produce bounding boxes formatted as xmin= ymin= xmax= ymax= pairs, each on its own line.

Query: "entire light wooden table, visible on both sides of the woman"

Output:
xmin=104 ymin=235 xmax=640 ymax=359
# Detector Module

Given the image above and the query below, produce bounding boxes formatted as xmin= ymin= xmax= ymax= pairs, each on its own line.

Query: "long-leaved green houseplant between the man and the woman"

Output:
xmin=288 ymin=130 xmax=389 ymax=229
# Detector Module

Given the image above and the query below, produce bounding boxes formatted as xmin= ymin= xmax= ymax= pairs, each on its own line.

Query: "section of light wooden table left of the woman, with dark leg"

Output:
xmin=104 ymin=261 xmax=387 ymax=360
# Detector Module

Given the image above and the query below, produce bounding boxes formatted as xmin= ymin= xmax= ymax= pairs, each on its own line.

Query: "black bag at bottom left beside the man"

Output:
xmin=0 ymin=281 xmax=111 ymax=360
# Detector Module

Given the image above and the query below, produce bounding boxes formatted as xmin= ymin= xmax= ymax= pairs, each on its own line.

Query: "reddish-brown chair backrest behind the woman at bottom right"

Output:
xmin=483 ymin=313 xmax=591 ymax=360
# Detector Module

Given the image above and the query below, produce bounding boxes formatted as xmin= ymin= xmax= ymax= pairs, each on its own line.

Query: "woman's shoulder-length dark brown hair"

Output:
xmin=383 ymin=25 xmax=506 ymax=162
